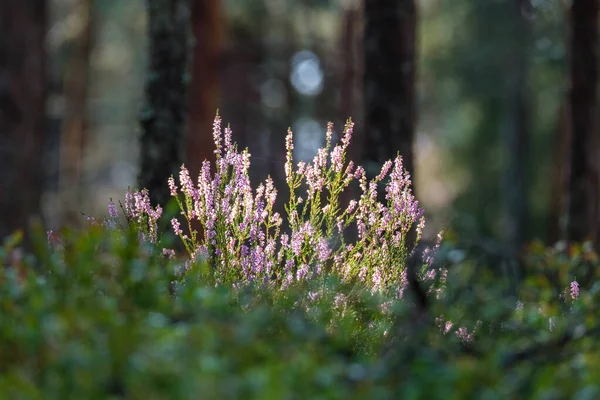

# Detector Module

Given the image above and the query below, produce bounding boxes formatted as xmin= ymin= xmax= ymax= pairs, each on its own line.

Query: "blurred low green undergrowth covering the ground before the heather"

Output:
xmin=0 ymin=226 xmax=600 ymax=399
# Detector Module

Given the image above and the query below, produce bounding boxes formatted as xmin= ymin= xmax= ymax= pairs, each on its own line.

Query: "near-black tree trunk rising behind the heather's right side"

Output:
xmin=364 ymin=0 xmax=417 ymax=189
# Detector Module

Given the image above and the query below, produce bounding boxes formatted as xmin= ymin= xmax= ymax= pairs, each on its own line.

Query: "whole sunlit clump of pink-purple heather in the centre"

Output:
xmin=165 ymin=116 xmax=441 ymax=297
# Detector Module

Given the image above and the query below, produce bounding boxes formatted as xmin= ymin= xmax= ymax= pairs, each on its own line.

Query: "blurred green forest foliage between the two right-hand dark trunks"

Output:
xmin=417 ymin=0 xmax=568 ymax=241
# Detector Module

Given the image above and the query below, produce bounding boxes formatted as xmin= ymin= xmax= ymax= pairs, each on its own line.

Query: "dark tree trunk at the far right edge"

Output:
xmin=566 ymin=0 xmax=599 ymax=241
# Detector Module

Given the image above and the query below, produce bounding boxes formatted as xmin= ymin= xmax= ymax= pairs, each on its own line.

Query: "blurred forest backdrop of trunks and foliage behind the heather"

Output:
xmin=0 ymin=0 xmax=599 ymax=255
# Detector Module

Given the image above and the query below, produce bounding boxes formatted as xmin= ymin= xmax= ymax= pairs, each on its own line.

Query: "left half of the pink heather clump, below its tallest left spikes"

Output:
xmin=169 ymin=116 xmax=283 ymax=283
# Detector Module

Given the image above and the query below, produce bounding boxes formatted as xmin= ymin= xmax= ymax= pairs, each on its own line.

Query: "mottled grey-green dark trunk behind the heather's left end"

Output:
xmin=138 ymin=0 xmax=191 ymax=205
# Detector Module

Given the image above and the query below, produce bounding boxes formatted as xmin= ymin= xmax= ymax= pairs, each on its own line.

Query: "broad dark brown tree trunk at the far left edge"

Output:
xmin=0 ymin=0 xmax=46 ymax=240
